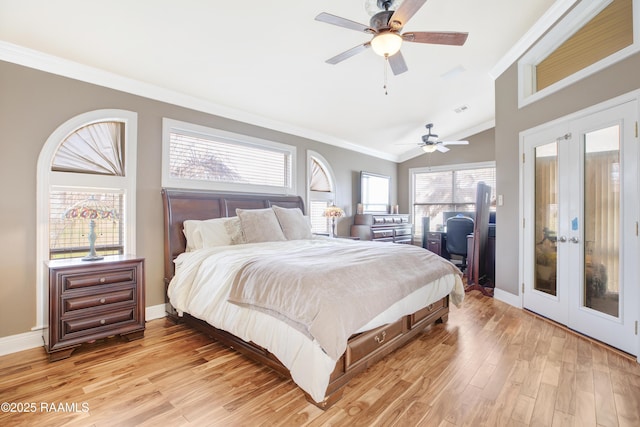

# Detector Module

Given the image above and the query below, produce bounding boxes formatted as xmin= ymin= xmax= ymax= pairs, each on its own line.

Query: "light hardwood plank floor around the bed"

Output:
xmin=0 ymin=291 xmax=640 ymax=427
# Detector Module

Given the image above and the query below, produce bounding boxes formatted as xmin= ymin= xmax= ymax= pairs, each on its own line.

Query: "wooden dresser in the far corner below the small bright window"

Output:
xmin=351 ymin=214 xmax=413 ymax=244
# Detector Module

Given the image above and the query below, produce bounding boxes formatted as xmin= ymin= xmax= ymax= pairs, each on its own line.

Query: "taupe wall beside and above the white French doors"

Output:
xmin=495 ymin=54 xmax=640 ymax=295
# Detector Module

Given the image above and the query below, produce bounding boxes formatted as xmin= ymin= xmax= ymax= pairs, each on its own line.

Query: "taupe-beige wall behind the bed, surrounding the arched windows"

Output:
xmin=0 ymin=61 xmax=397 ymax=337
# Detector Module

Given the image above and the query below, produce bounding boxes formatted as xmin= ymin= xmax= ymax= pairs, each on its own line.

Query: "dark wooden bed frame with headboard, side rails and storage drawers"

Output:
xmin=162 ymin=189 xmax=449 ymax=409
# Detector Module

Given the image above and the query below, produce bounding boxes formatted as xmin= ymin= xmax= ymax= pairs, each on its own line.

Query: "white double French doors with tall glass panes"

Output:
xmin=522 ymin=102 xmax=640 ymax=355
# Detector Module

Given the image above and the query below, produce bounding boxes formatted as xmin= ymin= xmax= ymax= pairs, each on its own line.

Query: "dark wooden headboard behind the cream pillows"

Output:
xmin=162 ymin=188 xmax=304 ymax=295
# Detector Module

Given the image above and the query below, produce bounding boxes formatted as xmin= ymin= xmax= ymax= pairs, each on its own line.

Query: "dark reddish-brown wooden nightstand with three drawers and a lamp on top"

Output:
xmin=43 ymin=255 xmax=145 ymax=361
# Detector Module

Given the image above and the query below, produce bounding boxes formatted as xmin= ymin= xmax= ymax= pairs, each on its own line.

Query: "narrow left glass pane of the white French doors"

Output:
xmin=534 ymin=142 xmax=558 ymax=296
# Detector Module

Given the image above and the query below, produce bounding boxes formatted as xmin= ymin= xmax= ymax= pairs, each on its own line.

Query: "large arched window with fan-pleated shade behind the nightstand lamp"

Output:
xmin=36 ymin=110 xmax=137 ymax=326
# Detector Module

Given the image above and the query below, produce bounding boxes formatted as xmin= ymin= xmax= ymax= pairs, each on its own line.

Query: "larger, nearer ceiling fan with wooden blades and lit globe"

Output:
xmin=316 ymin=0 xmax=468 ymax=75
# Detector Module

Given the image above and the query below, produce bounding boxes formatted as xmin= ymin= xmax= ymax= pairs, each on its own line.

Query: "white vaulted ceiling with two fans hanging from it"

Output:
xmin=0 ymin=0 xmax=566 ymax=161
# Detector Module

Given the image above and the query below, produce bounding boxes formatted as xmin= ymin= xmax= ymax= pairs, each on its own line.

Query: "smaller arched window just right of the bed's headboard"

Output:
xmin=307 ymin=151 xmax=336 ymax=234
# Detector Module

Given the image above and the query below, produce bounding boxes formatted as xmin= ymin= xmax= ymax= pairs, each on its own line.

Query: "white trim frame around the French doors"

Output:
xmin=518 ymin=89 xmax=640 ymax=363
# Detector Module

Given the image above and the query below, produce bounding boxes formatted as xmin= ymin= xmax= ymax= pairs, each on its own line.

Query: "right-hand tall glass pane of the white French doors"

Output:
xmin=583 ymin=125 xmax=621 ymax=317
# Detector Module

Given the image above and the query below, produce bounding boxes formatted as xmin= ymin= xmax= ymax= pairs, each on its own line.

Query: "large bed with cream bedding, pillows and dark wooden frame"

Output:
xmin=162 ymin=189 xmax=464 ymax=409
